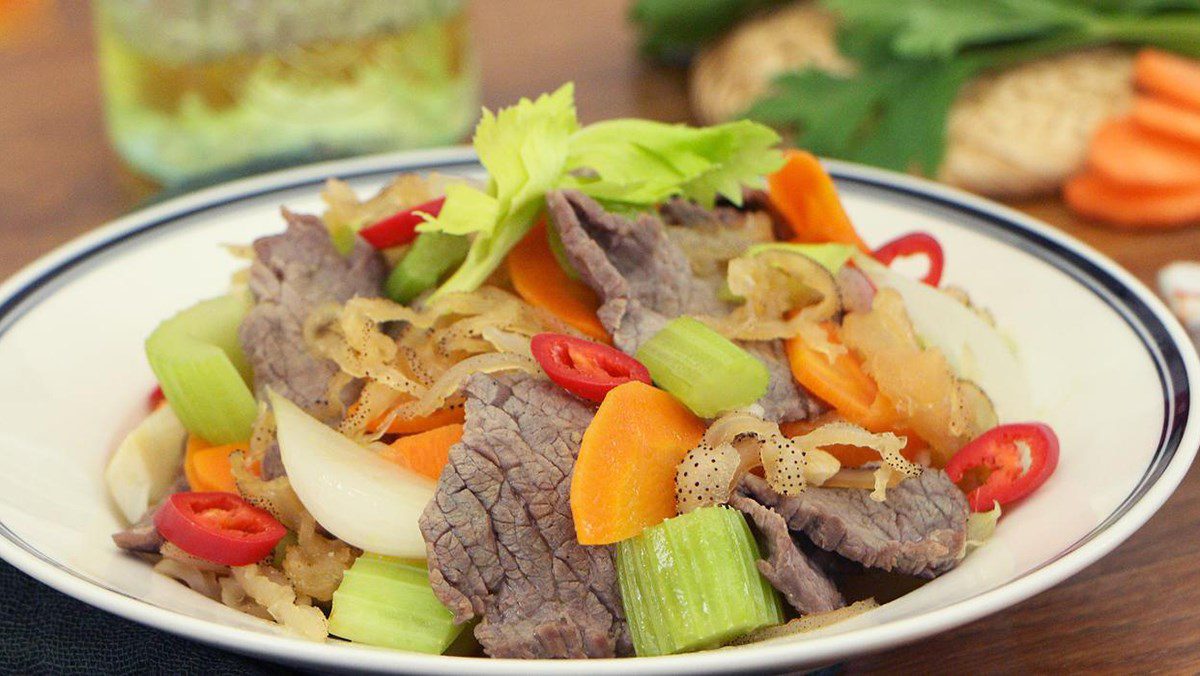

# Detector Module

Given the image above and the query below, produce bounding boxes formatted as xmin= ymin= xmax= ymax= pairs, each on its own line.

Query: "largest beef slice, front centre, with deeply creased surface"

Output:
xmin=420 ymin=375 xmax=632 ymax=658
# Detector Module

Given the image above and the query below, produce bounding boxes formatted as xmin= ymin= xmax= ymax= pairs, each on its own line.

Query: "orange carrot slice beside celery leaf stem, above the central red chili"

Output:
xmin=508 ymin=222 xmax=612 ymax=343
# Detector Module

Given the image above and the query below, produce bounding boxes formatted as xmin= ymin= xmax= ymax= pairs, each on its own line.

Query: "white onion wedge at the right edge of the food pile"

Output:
xmin=854 ymin=255 xmax=1032 ymax=423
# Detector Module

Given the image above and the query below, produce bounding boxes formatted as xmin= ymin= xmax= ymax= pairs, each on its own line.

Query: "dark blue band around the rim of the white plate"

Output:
xmin=0 ymin=154 xmax=1192 ymax=672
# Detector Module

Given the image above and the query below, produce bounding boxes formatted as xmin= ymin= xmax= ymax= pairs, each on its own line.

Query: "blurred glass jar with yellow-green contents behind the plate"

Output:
xmin=96 ymin=0 xmax=479 ymax=186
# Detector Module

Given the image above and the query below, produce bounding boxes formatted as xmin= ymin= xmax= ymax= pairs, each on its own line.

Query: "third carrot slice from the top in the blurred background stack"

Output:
xmin=1087 ymin=116 xmax=1200 ymax=187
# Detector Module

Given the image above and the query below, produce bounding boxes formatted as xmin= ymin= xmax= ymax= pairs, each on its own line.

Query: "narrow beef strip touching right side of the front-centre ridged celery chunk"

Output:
xmin=730 ymin=495 xmax=846 ymax=615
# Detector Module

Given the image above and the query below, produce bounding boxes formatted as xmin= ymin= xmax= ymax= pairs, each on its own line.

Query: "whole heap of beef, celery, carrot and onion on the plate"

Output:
xmin=106 ymin=85 xmax=1058 ymax=659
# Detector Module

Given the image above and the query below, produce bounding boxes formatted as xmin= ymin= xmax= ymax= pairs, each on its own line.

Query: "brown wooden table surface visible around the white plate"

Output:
xmin=0 ymin=0 xmax=1200 ymax=672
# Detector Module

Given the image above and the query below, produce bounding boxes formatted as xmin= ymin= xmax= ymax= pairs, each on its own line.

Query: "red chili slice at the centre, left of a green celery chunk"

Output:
xmin=530 ymin=334 xmax=650 ymax=401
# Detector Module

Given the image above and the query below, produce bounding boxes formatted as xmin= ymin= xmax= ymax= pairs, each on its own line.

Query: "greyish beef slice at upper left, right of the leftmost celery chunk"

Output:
xmin=239 ymin=210 xmax=388 ymax=412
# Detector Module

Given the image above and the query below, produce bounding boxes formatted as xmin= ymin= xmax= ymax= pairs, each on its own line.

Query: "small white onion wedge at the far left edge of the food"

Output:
xmin=104 ymin=405 xmax=187 ymax=524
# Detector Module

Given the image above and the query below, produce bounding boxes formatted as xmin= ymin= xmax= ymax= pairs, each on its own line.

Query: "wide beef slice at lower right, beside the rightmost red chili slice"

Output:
xmin=740 ymin=469 xmax=967 ymax=578
